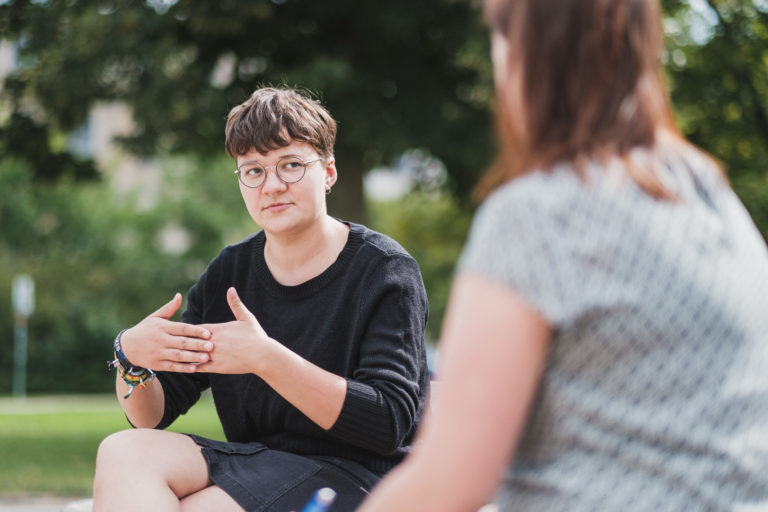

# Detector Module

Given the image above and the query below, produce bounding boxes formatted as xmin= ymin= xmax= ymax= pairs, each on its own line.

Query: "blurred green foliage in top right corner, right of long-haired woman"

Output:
xmin=664 ymin=0 xmax=768 ymax=238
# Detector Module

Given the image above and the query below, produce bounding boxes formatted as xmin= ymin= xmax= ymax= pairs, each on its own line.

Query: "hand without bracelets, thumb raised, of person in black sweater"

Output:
xmin=198 ymin=287 xmax=277 ymax=375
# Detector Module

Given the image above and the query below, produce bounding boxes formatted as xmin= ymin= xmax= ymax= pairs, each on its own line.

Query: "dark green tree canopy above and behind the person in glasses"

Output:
xmin=0 ymin=0 xmax=492 ymax=220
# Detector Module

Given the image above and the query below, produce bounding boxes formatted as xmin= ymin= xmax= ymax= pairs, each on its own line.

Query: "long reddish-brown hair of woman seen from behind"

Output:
xmin=476 ymin=0 xmax=716 ymax=202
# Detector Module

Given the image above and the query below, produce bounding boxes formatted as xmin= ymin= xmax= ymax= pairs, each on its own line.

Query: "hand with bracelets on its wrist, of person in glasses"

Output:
xmin=120 ymin=293 xmax=213 ymax=373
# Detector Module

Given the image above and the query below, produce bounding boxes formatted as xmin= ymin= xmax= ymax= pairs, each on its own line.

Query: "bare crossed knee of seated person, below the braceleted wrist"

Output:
xmin=93 ymin=429 xmax=211 ymax=512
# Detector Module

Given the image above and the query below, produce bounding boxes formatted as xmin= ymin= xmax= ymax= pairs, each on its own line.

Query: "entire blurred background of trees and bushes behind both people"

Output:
xmin=0 ymin=0 xmax=768 ymax=395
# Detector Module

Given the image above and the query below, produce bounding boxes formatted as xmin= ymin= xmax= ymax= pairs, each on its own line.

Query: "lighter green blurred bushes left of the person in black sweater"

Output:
xmin=0 ymin=157 xmax=249 ymax=393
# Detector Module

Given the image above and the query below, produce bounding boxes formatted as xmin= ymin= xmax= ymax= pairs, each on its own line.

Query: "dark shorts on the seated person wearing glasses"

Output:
xmin=190 ymin=435 xmax=381 ymax=512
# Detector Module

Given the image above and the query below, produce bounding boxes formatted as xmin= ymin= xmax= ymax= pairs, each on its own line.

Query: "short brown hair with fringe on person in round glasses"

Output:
xmin=225 ymin=87 xmax=336 ymax=159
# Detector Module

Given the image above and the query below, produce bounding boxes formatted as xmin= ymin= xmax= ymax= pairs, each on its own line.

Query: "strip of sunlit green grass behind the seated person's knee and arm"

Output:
xmin=0 ymin=394 xmax=224 ymax=497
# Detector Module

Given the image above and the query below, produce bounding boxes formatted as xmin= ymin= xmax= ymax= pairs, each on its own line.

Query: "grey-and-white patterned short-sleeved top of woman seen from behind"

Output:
xmin=460 ymin=152 xmax=768 ymax=512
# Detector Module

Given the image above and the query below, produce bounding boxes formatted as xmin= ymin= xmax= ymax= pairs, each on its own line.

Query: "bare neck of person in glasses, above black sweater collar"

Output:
xmin=264 ymin=215 xmax=349 ymax=286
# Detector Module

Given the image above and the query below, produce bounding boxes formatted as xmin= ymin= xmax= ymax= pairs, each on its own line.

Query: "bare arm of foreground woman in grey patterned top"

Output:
xmin=359 ymin=274 xmax=550 ymax=512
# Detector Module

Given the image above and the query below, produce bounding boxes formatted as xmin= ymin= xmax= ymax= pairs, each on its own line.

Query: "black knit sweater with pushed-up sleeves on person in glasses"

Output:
xmin=158 ymin=224 xmax=428 ymax=474
